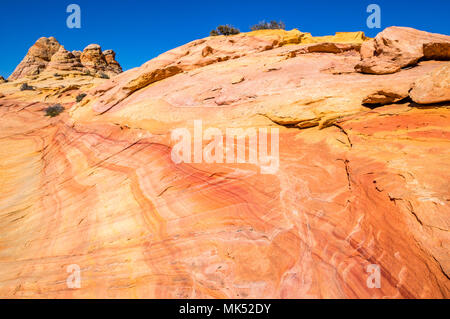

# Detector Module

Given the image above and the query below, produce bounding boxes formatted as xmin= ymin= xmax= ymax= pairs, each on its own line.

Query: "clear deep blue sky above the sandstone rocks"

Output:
xmin=0 ymin=0 xmax=450 ymax=77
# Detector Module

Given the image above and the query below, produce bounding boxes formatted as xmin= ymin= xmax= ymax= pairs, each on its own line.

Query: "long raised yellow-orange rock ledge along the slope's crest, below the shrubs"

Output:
xmin=87 ymin=29 xmax=368 ymax=111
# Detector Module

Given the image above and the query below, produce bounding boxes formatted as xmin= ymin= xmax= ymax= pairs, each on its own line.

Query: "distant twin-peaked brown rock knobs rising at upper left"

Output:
xmin=9 ymin=37 xmax=122 ymax=80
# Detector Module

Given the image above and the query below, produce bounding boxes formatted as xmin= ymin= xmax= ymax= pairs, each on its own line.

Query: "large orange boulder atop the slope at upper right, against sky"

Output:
xmin=356 ymin=27 xmax=450 ymax=74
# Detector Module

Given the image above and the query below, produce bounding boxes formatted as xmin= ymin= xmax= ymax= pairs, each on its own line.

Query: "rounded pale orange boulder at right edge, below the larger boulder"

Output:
xmin=409 ymin=64 xmax=450 ymax=104
